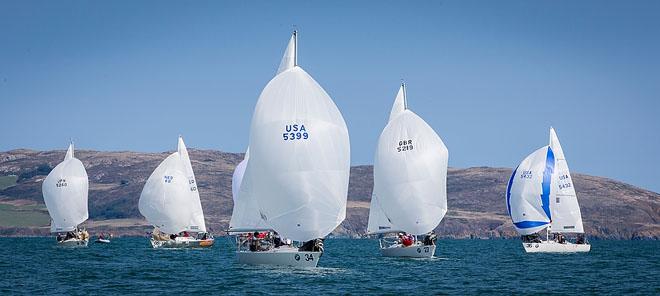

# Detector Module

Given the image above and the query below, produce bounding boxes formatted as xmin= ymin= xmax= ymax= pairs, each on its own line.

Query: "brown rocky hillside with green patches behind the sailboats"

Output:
xmin=0 ymin=149 xmax=660 ymax=239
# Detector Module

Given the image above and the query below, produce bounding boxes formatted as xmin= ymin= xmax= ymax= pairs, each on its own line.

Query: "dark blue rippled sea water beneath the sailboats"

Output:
xmin=0 ymin=237 xmax=660 ymax=295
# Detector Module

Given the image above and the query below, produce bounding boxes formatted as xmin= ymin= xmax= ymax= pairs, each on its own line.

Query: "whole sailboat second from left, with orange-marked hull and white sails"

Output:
xmin=138 ymin=136 xmax=214 ymax=248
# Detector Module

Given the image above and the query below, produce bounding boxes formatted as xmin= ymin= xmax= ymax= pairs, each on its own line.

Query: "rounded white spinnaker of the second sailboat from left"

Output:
xmin=138 ymin=143 xmax=193 ymax=234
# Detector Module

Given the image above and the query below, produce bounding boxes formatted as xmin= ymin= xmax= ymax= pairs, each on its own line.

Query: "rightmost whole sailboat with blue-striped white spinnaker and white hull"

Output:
xmin=506 ymin=127 xmax=591 ymax=253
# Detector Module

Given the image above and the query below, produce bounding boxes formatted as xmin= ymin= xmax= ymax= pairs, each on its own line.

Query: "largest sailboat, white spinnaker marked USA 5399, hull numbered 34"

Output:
xmin=229 ymin=31 xmax=350 ymax=267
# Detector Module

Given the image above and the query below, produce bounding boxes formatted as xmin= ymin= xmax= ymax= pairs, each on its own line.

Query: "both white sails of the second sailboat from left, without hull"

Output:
xmin=138 ymin=138 xmax=206 ymax=233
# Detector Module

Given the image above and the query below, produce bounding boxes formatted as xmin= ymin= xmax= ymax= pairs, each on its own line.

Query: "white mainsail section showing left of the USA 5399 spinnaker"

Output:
xmin=229 ymin=148 xmax=269 ymax=232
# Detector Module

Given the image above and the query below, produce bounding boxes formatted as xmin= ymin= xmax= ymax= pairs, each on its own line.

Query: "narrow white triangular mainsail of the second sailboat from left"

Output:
xmin=177 ymin=136 xmax=206 ymax=232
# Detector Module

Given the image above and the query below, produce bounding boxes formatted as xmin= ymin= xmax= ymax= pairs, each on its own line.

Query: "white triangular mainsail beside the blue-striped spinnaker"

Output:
xmin=550 ymin=128 xmax=584 ymax=233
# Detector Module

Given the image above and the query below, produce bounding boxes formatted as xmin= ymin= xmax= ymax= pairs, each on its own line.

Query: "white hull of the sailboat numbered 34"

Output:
xmin=236 ymin=247 xmax=323 ymax=267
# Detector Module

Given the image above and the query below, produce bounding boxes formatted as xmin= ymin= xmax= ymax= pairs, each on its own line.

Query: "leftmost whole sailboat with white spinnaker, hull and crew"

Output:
xmin=41 ymin=143 xmax=89 ymax=246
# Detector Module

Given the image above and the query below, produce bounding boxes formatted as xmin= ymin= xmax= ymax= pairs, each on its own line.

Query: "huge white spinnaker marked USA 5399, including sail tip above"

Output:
xmin=239 ymin=32 xmax=350 ymax=241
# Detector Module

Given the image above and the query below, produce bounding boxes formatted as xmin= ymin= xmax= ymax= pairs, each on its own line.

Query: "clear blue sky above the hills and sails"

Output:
xmin=0 ymin=0 xmax=660 ymax=192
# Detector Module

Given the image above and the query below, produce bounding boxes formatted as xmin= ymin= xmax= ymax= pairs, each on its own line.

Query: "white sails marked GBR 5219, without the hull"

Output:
xmin=370 ymin=85 xmax=449 ymax=234
